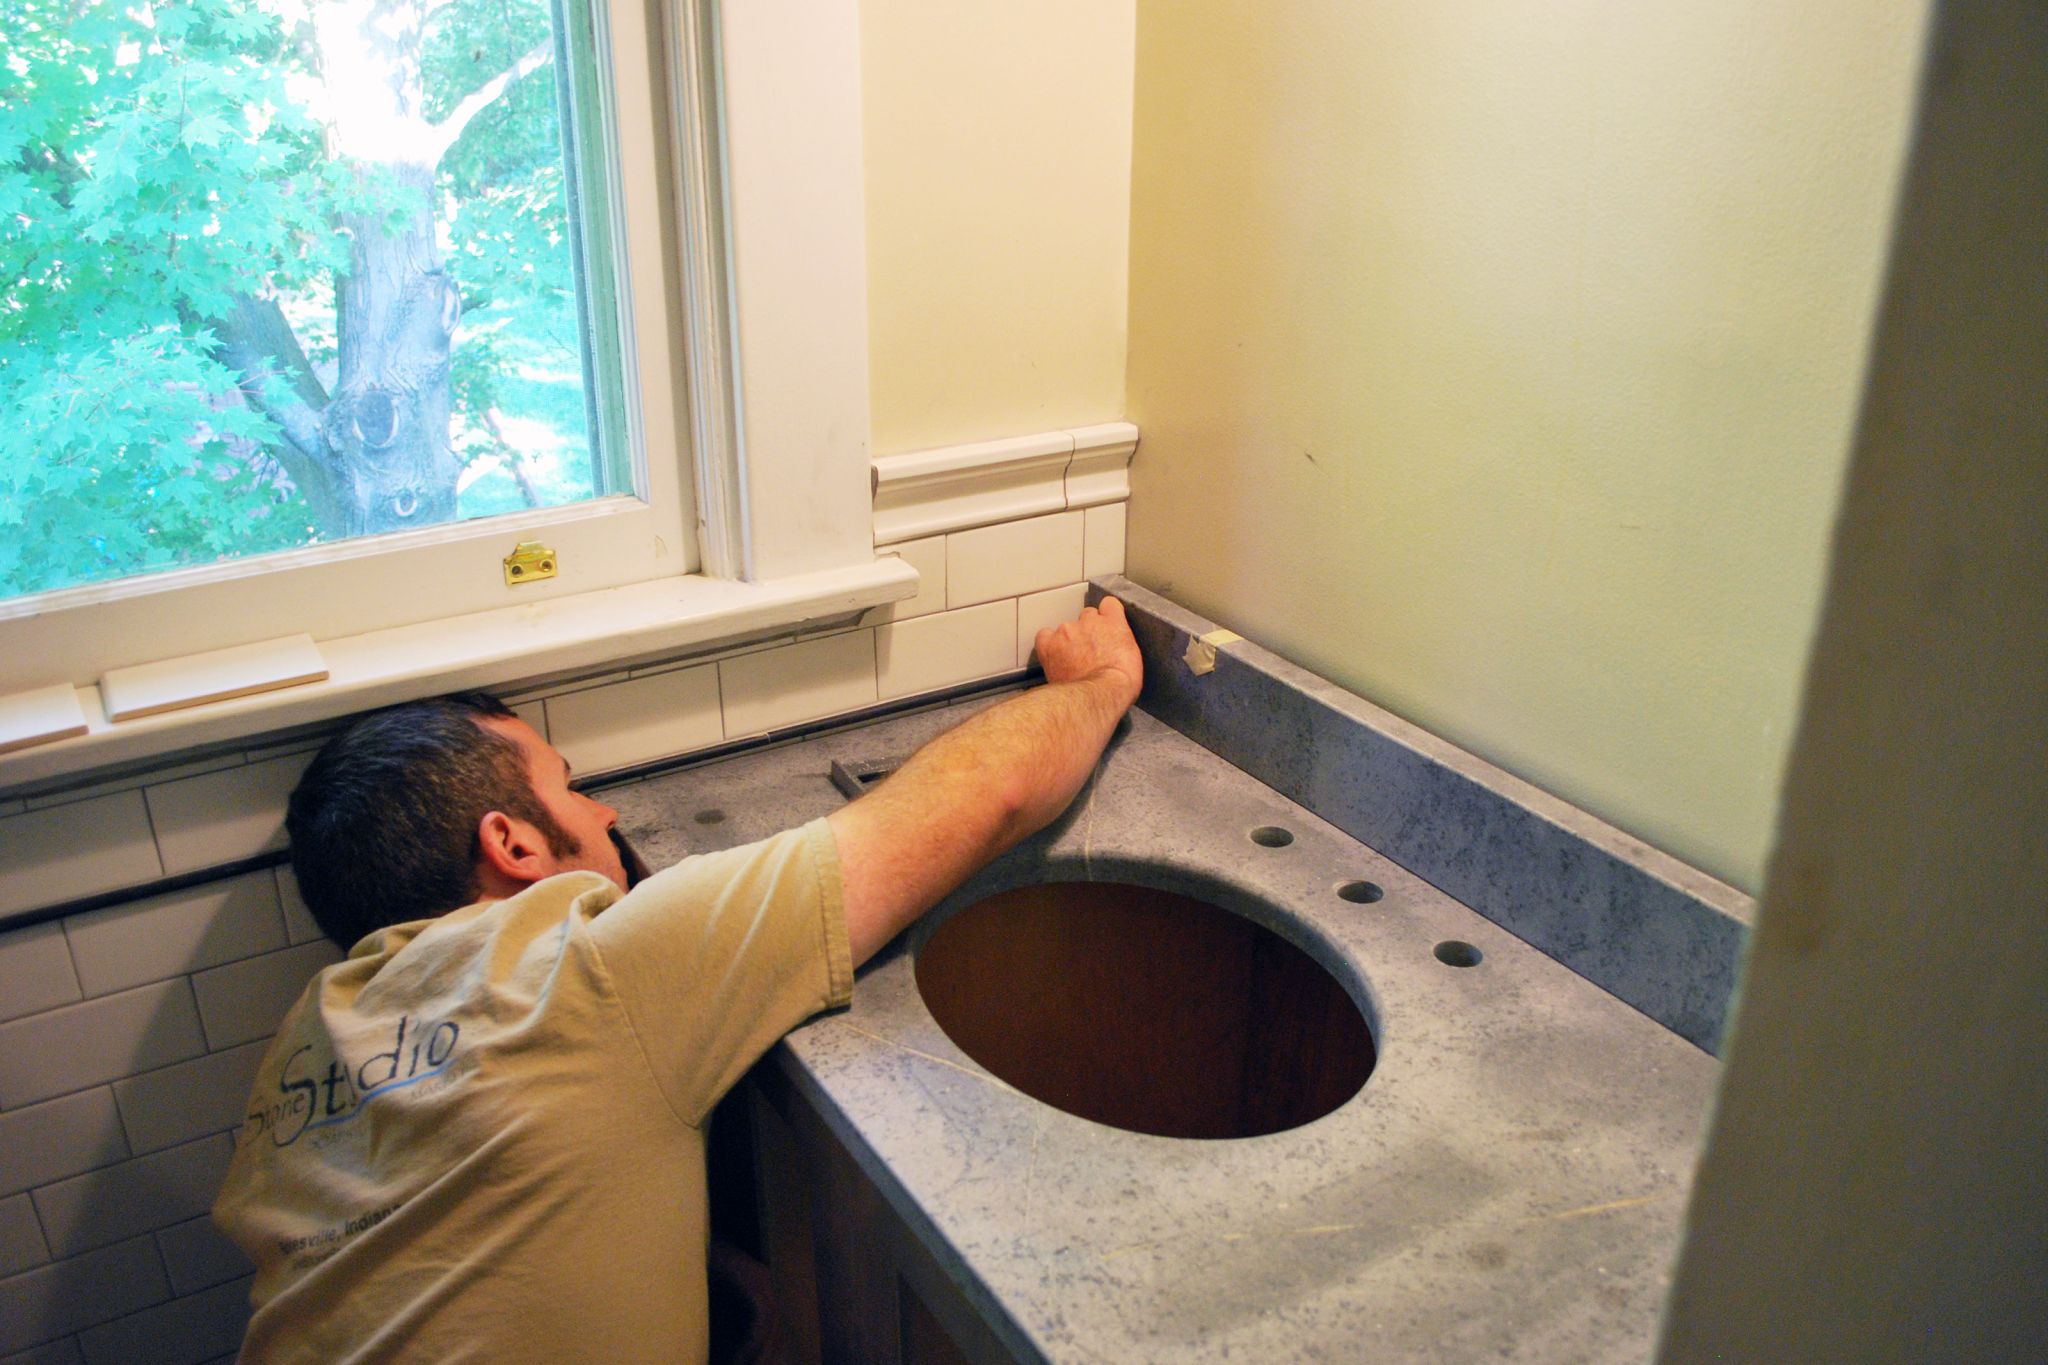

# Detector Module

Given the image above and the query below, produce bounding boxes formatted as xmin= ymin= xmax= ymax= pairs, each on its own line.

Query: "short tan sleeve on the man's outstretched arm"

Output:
xmin=590 ymin=819 xmax=854 ymax=1124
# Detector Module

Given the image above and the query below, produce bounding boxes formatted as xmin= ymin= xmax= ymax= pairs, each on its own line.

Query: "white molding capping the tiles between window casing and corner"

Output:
xmin=872 ymin=422 xmax=1139 ymax=544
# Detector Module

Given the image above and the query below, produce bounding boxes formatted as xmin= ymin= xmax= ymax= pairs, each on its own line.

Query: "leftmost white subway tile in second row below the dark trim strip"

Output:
xmin=0 ymin=986 xmax=205 ymax=1109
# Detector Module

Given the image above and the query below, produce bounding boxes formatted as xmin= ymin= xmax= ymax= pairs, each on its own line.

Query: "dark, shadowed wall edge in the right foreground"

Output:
xmin=1659 ymin=0 xmax=2048 ymax=1365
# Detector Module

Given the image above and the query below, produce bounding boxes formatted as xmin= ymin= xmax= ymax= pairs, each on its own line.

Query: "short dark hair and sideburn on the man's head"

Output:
xmin=285 ymin=692 xmax=573 ymax=952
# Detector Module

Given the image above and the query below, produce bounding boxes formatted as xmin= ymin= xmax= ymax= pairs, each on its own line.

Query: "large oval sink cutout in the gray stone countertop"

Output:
xmin=915 ymin=882 xmax=1376 ymax=1138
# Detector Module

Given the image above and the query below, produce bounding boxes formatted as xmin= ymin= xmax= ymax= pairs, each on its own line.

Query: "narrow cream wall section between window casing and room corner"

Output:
xmin=860 ymin=0 xmax=1135 ymax=454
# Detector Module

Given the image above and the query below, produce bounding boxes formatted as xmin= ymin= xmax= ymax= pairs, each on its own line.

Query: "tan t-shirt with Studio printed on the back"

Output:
xmin=213 ymin=821 xmax=852 ymax=1363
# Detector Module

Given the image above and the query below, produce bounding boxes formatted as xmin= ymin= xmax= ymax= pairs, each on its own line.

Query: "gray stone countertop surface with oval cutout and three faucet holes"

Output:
xmin=606 ymin=698 xmax=1718 ymax=1361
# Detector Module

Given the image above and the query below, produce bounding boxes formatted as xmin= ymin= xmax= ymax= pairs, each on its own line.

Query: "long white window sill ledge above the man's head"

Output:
xmin=0 ymin=559 xmax=918 ymax=794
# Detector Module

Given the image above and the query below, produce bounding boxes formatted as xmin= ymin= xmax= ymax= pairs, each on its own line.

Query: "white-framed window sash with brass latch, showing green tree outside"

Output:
xmin=0 ymin=0 xmax=696 ymax=692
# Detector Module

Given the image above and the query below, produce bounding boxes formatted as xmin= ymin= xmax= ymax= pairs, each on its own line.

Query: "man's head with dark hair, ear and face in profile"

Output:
xmin=285 ymin=692 xmax=627 ymax=950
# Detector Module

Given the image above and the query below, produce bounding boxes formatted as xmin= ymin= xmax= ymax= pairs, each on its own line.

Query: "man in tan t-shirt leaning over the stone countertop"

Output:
xmin=213 ymin=598 xmax=1143 ymax=1361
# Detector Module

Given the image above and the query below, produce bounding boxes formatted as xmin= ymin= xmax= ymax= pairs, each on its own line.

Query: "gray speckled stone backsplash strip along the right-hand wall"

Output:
xmin=1090 ymin=577 xmax=1755 ymax=1052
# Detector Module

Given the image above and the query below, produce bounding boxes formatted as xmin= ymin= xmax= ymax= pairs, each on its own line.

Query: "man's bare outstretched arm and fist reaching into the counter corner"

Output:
xmin=829 ymin=598 xmax=1145 ymax=966
